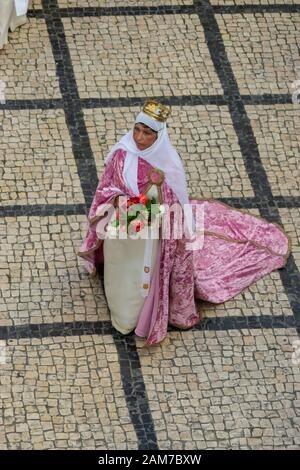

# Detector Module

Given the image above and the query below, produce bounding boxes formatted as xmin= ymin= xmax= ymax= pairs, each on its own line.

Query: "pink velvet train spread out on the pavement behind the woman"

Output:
xmin=192 ymin=200 xmax=289 ymax=303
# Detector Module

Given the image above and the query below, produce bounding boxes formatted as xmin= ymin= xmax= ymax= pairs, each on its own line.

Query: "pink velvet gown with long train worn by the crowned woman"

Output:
xmin=78 ymin=149 xmax=290 ymax=345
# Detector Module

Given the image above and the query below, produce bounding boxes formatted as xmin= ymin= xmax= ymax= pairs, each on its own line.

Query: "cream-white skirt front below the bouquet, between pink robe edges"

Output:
xmin=103 ymin=185 xmax=159 ymax=334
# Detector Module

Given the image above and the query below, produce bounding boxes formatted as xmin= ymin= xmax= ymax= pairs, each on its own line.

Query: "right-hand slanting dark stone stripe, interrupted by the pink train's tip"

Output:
xmin=194 ymin=0 xmax=300 ymax=333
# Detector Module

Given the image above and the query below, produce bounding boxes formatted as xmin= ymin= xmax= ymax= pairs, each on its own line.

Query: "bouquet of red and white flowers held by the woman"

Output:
xmin=107 ymin=193 xmax=163 ymax=237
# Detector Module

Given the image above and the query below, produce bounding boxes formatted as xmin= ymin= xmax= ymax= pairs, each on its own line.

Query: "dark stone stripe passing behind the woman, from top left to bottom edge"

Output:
xmin=41 ymin=0 xmax=158 ymax=449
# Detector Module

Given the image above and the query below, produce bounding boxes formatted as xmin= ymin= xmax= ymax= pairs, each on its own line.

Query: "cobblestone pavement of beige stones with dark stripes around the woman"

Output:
xmin=0 ymin=0 xmax=300 ymax=450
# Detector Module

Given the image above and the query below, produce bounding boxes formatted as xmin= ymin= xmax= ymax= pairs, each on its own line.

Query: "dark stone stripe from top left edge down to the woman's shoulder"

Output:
xmin=42 ymin=0 xmax=98 ymax=208
